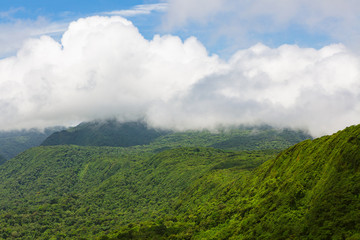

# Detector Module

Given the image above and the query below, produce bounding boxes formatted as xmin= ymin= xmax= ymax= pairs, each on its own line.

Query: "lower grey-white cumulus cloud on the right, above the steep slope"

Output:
xmin=146 ymin=44 xmax=360 ymax=136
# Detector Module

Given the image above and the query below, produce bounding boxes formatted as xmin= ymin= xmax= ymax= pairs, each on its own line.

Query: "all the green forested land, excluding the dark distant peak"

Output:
xmin=0 ymin=125 xmax=360 ymax=239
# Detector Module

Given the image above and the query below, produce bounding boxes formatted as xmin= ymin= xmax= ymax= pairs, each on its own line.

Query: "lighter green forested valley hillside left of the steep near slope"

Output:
xmin=0 ymin=146 xmax=270 ymax=239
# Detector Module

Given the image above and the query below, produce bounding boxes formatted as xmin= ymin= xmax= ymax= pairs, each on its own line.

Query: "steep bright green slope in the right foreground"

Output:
xmin=108 ymin=125 xmax=360 ymax=239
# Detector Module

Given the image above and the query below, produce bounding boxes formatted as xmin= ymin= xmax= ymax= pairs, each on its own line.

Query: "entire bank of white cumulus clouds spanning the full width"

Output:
xmin=0 ymin=17 xmax=360 ymax=135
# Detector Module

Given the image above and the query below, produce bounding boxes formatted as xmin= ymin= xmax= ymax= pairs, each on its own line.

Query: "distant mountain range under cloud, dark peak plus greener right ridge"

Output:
xmin=41 ymin=120 xmax=312 ymax=151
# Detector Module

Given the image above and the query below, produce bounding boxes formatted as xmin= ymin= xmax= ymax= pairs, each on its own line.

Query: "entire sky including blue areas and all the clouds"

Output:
xmin=0 ymin=0 xmax=360 ymax=136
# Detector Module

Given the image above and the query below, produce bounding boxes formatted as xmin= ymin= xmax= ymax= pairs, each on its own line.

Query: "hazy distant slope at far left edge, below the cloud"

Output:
xmin=0 ymin=127 xmax=63 ymax=159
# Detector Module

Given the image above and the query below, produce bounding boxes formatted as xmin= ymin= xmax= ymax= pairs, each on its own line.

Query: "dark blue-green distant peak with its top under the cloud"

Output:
xmin=41 ymin=120 xmax=168 ymax=147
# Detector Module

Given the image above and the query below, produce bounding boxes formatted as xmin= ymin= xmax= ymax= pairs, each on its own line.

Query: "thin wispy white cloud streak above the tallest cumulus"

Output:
xmin=103 ymin=3 xmax=167 ymax=17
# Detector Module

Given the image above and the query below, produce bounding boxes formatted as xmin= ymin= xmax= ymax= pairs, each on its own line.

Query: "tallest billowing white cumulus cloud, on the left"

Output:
xmin=0 ymin=17 xmax=219 ymax=128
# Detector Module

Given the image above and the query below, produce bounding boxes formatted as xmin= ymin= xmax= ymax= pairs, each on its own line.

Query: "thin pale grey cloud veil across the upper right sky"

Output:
xmin=164 ymin=0 xmax=360 ymax=50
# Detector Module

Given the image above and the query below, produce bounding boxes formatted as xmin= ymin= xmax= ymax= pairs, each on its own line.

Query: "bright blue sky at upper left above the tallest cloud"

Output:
xmin=0 ymin=0 xmax=165 ymax=56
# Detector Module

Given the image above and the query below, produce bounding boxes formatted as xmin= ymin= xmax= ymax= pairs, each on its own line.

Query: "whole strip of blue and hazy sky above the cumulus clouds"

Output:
xmin=0 ymin=0 xmax=358 ymax=57
